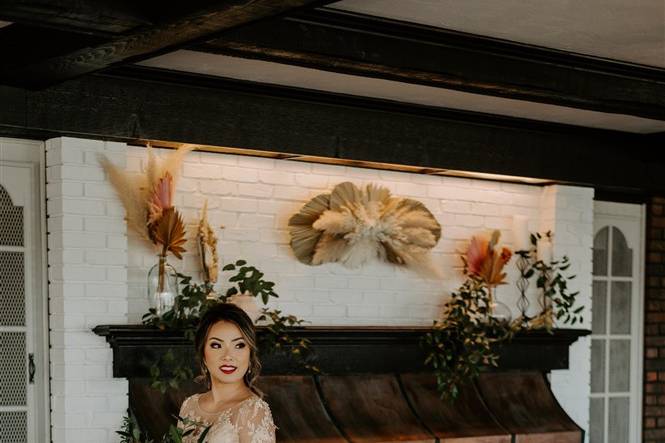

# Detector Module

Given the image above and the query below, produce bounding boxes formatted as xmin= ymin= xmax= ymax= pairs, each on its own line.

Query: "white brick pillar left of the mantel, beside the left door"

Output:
xmin=46 ymin=138 xmax=127 ymax=443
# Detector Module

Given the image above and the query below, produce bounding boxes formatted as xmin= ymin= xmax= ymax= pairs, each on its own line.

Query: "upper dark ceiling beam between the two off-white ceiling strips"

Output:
xmin=196 ymin=8 xmax=665 ymax=120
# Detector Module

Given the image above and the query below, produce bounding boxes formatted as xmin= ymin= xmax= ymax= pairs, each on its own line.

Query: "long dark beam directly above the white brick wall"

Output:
xmin=0 ymin=67 xmax=665 ymax=193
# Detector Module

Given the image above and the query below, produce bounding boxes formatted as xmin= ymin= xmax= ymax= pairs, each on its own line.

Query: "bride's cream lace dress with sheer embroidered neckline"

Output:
xmin=178 ymin=394 xmax=276 ymax=443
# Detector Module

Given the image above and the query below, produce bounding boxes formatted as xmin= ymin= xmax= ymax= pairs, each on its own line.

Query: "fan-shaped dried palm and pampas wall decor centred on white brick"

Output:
xmin=289 ymin=182 xmax=441 ymax=275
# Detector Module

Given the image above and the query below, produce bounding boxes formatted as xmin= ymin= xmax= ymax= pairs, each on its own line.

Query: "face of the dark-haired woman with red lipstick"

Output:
xmin=203 ymin=321 xmax=250 ymax=383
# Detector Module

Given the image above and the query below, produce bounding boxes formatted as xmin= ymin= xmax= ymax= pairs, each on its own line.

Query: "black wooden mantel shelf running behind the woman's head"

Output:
xmin=94 ymin=325 xmax=590 ymax=378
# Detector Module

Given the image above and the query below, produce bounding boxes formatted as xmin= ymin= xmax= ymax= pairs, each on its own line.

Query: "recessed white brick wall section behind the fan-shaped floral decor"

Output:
xmin=127 ymin=147 xmax=542 ymax=325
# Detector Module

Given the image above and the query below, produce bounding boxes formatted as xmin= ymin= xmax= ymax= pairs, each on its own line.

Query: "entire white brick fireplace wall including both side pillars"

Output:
xmin=47 ymin=138 xmax=593 ymax=442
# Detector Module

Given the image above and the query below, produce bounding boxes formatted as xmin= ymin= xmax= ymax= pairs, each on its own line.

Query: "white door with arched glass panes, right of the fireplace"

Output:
xmin=589 ymin=205 xmax=641 ymax=443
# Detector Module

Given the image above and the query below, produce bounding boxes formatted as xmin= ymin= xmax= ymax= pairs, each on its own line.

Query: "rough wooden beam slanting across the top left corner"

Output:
xmin=0 ymin=0 xmax=338 ymax=89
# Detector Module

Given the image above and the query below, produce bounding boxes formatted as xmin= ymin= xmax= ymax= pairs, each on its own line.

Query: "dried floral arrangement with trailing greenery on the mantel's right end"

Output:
xmin=421 ymin=231 xmax=583 ymax=401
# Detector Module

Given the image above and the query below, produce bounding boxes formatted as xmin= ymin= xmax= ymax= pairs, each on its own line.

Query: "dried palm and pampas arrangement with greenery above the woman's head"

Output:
xmin=99 ymin=145 xmax=318 ymax=400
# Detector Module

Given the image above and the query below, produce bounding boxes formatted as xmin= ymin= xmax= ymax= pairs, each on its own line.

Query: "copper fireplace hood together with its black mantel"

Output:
xmin=95 ymin=326 xmax=588 ymax=443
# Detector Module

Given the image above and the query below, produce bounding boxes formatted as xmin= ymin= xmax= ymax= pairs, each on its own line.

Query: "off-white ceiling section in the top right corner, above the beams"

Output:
xmin=331 ymin=0 xmax=665 ymax=68
